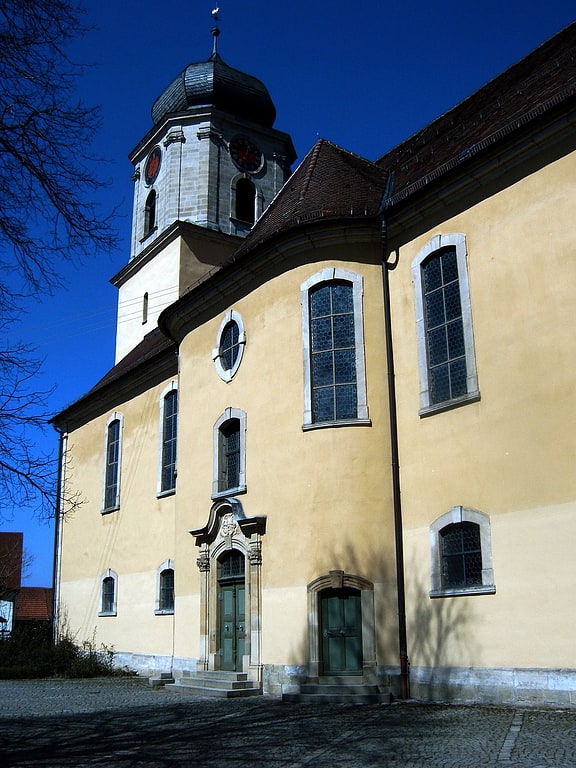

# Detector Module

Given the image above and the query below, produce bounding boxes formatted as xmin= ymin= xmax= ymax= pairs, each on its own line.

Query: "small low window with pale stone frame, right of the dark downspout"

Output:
xmin=430 ymin=507 xmax=496 ymax=597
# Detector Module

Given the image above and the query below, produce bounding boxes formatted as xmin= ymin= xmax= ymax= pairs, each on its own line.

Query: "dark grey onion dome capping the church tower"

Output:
xmin=152 ymin=51 xmax=276 ymax=128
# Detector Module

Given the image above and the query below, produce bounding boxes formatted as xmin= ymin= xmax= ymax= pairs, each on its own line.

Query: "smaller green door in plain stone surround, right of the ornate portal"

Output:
xmin=320 ymin=589 xmax=362 ymax=675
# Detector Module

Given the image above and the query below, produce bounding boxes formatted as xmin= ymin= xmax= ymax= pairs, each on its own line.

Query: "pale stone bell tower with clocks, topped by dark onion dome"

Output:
xmin=112 ymin=12 xmax=296 ymax=362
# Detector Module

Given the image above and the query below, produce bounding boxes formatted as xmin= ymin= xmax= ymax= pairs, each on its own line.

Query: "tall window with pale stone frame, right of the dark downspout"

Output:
xmin=412 ymin=233 xmax=480 ymax=415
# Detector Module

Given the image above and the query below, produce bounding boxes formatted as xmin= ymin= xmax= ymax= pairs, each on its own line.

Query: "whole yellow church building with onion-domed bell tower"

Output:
xmin=53 ymin=24 xmax=576 ymax=705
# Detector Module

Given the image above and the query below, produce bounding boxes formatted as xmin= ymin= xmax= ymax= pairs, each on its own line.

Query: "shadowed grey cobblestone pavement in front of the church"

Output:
xmin=0 ymin=679 xmax=576 ymax=768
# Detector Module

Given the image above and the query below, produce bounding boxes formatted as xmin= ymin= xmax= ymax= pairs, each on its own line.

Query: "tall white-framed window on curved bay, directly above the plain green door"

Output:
xmin=300 ymin=268 xmax=369 ymax=429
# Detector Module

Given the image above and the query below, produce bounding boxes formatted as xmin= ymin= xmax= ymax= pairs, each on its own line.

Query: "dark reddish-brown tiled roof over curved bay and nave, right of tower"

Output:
xmin=232 ymin=23 xmax=576 ymax=261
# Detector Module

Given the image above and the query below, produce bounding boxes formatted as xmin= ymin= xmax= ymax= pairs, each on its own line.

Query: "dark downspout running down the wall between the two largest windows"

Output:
xmin=378 ymin=174 xmax=410 ymax=699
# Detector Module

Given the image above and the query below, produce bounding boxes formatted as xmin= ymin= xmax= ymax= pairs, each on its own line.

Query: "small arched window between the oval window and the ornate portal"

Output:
xmin=212 ymin=408 xmax=246 ymax=498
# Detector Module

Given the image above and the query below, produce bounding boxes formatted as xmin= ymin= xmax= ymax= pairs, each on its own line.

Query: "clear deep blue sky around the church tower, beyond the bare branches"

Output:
xmin=2 ymin=0 xmax=576 ymax=586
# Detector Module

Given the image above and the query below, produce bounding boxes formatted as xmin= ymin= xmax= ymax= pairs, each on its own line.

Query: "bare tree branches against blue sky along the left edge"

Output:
xmin=0 ymin=0 xmax=116 ymax=519
